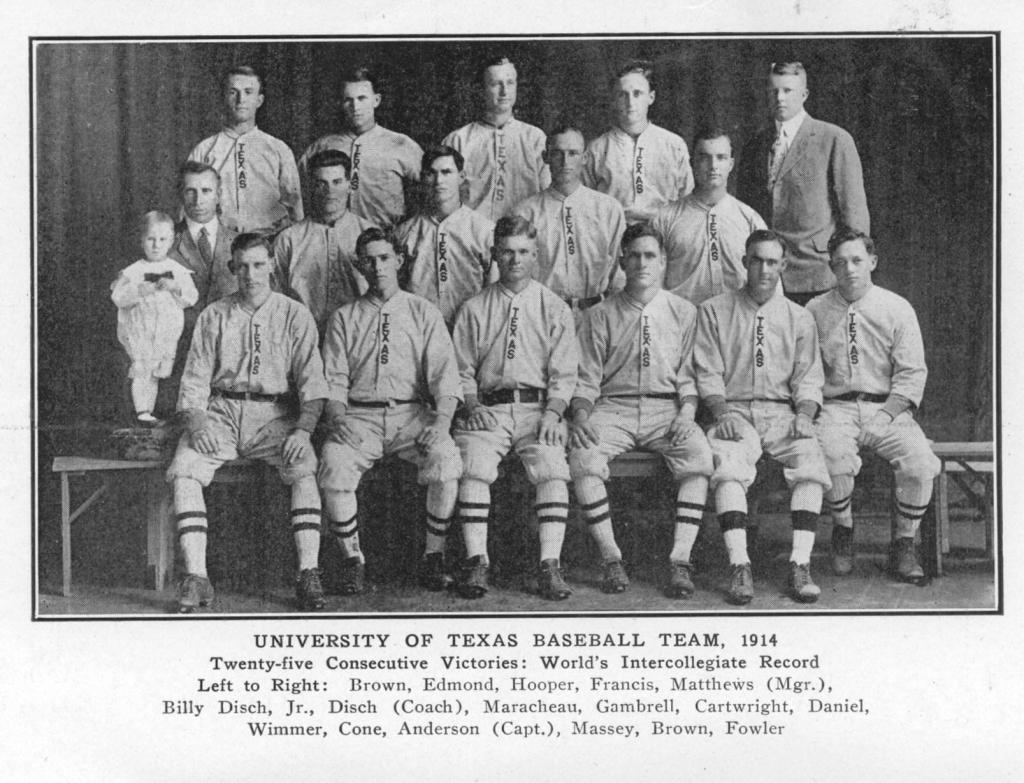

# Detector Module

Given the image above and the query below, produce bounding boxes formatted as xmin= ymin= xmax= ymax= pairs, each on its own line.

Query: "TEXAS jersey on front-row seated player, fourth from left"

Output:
xmin=574 ymin=290 xmax=697 ymax=403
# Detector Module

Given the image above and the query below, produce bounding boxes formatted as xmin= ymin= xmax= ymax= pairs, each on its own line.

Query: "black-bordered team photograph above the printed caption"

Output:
xmin=30 ymin=34 xmax=1002 ymax=620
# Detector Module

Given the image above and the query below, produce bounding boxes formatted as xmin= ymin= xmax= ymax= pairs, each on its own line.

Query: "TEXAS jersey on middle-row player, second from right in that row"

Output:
xmin=513 ymin=185 xmax=626 ymax=299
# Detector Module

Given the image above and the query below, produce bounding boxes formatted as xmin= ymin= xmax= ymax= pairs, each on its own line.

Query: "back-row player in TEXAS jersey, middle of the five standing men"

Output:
xmin=443 ymin=57 xmax=551 ymax=220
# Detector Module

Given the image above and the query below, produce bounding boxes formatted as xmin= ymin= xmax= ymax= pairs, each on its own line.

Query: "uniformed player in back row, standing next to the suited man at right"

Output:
xmin=583 ymin=60 xmax=693 ymax=223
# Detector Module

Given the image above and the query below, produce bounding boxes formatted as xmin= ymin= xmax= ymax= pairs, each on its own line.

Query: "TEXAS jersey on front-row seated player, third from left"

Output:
xmin=453 ymin=280 xmax=579 ymax=404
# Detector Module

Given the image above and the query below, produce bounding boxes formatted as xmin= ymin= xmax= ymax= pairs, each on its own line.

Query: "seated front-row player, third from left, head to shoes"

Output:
xmin=454 ymin=216 xmax=578 ymax=601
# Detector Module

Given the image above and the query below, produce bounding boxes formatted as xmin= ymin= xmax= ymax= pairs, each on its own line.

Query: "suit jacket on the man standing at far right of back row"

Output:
xmin=737 ymin=115 xmax=870 ymax=292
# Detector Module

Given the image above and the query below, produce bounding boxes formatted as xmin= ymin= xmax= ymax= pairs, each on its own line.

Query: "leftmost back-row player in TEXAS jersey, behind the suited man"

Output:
xmin=188 ymin=66 xmax=303 ymax=234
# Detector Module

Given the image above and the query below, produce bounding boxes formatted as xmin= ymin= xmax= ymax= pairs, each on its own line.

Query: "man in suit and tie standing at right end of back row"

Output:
xmin=737 ymin=62 xmax=870 ymax=304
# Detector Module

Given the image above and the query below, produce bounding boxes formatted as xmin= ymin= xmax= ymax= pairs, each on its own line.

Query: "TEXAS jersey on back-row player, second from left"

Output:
xmin=299 ymin=125 xmax=423 ymax=228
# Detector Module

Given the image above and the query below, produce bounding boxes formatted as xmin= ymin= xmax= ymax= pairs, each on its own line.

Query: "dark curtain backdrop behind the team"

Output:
xmin=35 ymin=37 xmax=994 ymax=439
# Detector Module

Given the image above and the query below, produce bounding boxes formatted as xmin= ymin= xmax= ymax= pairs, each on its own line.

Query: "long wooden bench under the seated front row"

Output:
xmin=52 ymin=442 xmax=993 ymax=596
